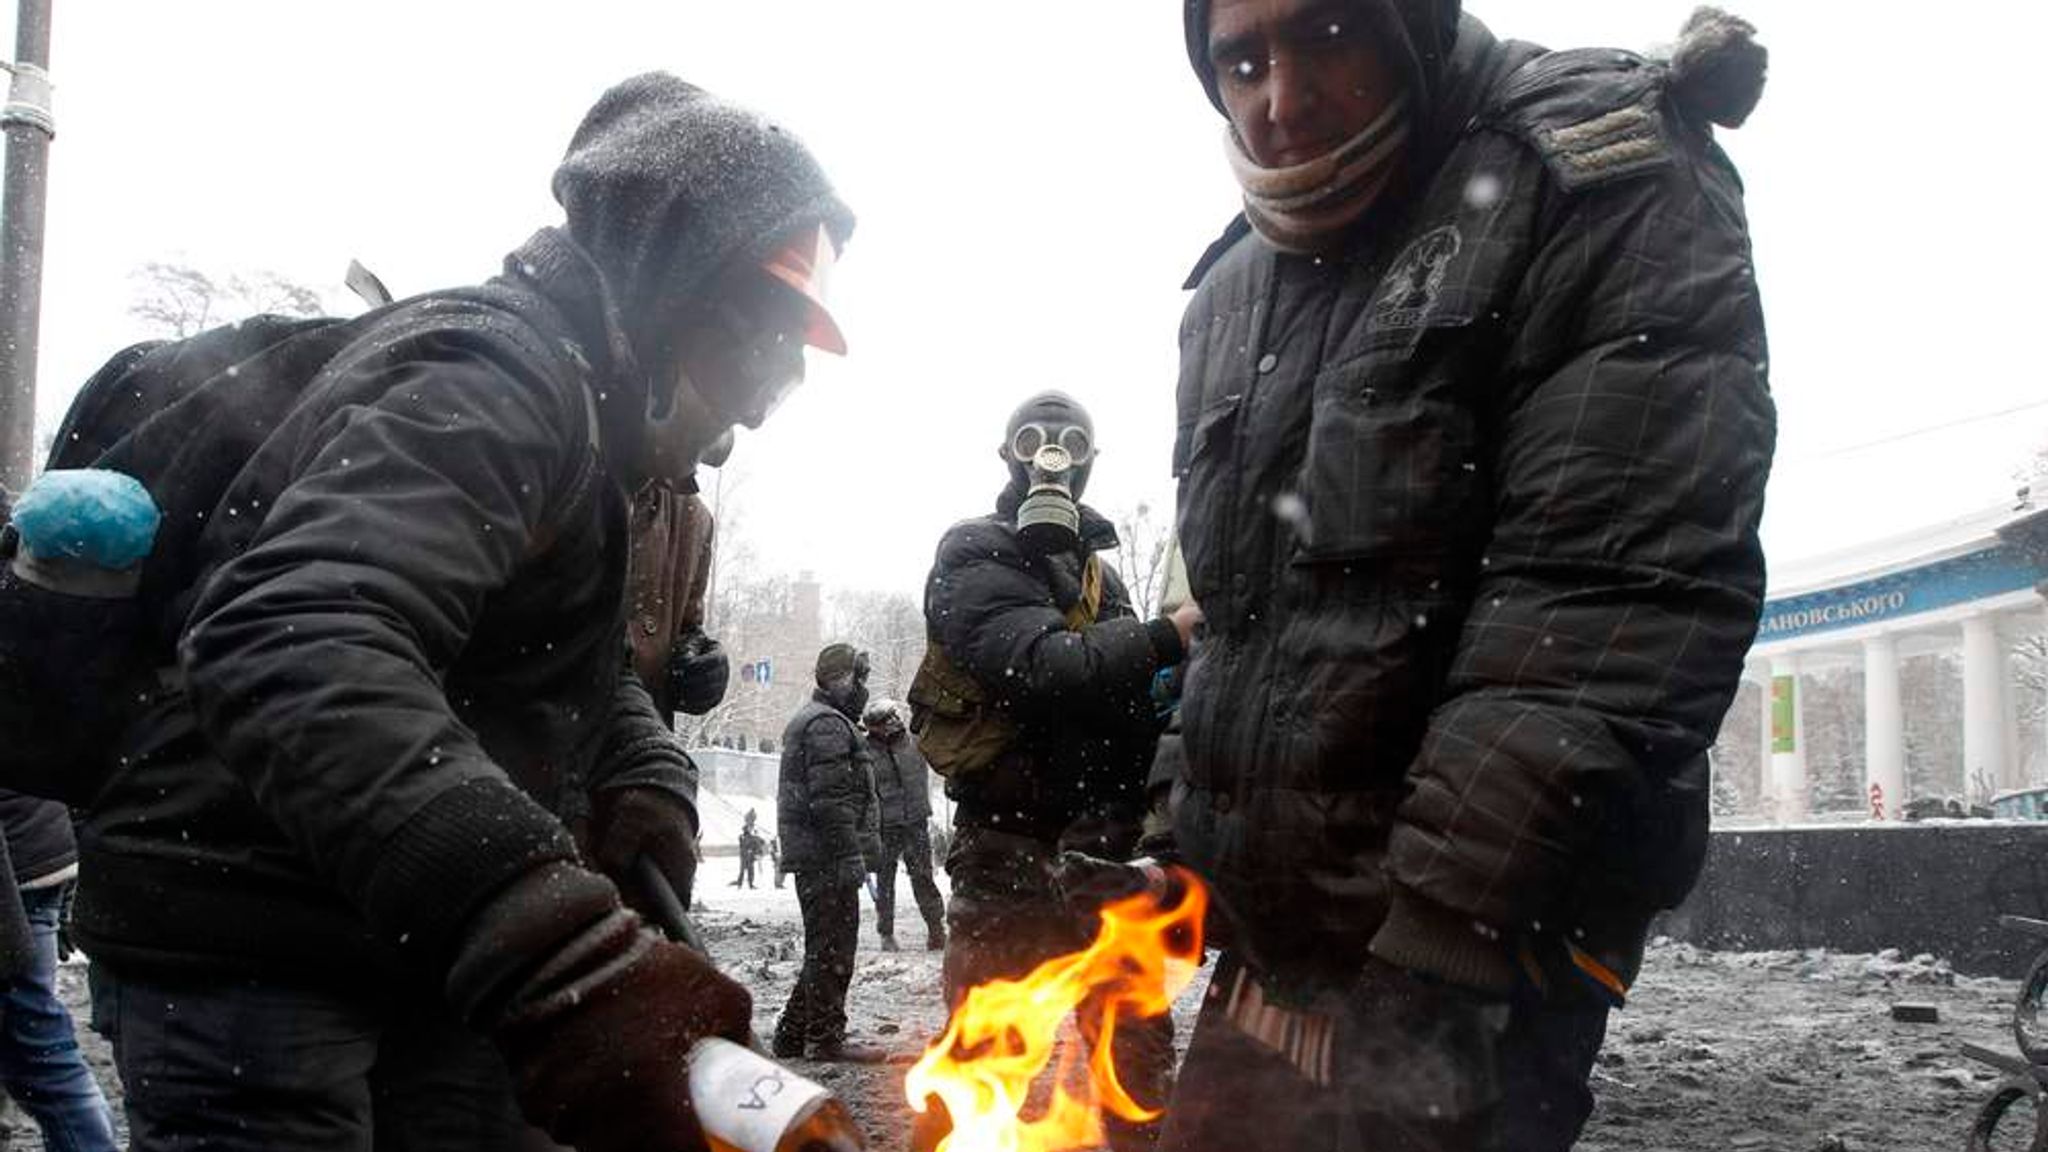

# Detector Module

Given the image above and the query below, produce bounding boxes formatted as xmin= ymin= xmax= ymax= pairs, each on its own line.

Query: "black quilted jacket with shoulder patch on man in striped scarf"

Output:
xmin=1174 ymin=18 xmax=1774 ymax=994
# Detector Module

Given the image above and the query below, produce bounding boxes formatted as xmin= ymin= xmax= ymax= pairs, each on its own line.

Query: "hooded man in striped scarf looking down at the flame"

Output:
xmin=1163 ymin=0 xmax=1774 ymax=1152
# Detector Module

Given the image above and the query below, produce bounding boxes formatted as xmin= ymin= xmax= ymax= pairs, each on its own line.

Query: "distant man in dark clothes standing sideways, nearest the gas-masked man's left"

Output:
xmin=774 ymin=644 xmax=885 ymax=1064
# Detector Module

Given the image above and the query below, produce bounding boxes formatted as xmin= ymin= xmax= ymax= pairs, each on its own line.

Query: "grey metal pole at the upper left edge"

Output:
xmin=0 ymin=0 xmax=57 ymax=492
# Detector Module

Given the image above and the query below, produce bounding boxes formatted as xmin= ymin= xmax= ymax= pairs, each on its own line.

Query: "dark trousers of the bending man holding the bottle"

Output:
xmin=92 ymin=965 xmax=557 ymax=1152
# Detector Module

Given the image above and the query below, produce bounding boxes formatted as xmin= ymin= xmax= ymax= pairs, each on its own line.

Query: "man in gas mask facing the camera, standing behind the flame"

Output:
xmin=909 ymin=392 xmax=1198 ymax=1152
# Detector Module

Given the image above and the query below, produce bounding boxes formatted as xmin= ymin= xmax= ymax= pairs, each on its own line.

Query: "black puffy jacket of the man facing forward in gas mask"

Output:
xmin=924 ymin=490 xmax=1182 ymax=840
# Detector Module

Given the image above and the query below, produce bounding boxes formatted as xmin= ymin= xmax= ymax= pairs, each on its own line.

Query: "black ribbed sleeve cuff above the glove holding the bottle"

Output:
xmin=362 ymin=775 xmax=575 ymax=974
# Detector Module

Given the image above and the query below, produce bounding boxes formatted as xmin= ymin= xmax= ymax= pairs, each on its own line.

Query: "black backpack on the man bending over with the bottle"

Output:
xmin=0 ymin=303 xmax=596 ymax=808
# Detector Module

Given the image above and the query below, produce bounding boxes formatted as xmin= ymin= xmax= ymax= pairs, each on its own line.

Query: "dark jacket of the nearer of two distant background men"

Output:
xmin=776 ymin=691 xmax=881 ymax=877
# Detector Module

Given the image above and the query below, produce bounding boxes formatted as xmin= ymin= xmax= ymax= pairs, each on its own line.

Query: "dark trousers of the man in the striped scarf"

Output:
xmin=1159 ymin=957 xmax=1608 ymax=1152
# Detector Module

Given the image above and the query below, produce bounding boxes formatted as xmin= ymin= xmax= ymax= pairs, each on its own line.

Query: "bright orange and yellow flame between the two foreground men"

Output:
xmin=903 ymin=867 xmax=1208 ymax=1152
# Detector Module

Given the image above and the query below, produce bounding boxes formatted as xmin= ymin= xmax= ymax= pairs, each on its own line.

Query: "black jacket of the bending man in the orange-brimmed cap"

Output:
xmin=76 ymin=230 xmax=694 ymax=982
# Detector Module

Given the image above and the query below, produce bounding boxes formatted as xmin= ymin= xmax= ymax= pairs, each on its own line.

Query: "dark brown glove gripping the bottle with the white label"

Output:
xmin=492 ymin=920 xmax=754 ymax=1152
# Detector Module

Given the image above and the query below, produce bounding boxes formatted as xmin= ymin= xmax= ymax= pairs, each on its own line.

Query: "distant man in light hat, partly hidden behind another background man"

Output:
xmin=860 ymin=701 xmax=946 ymax=951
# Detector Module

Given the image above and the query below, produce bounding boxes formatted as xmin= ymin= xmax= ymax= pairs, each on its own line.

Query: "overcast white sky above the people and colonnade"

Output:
xmin=0 ymin=0 xmax=2048 ymax=592
